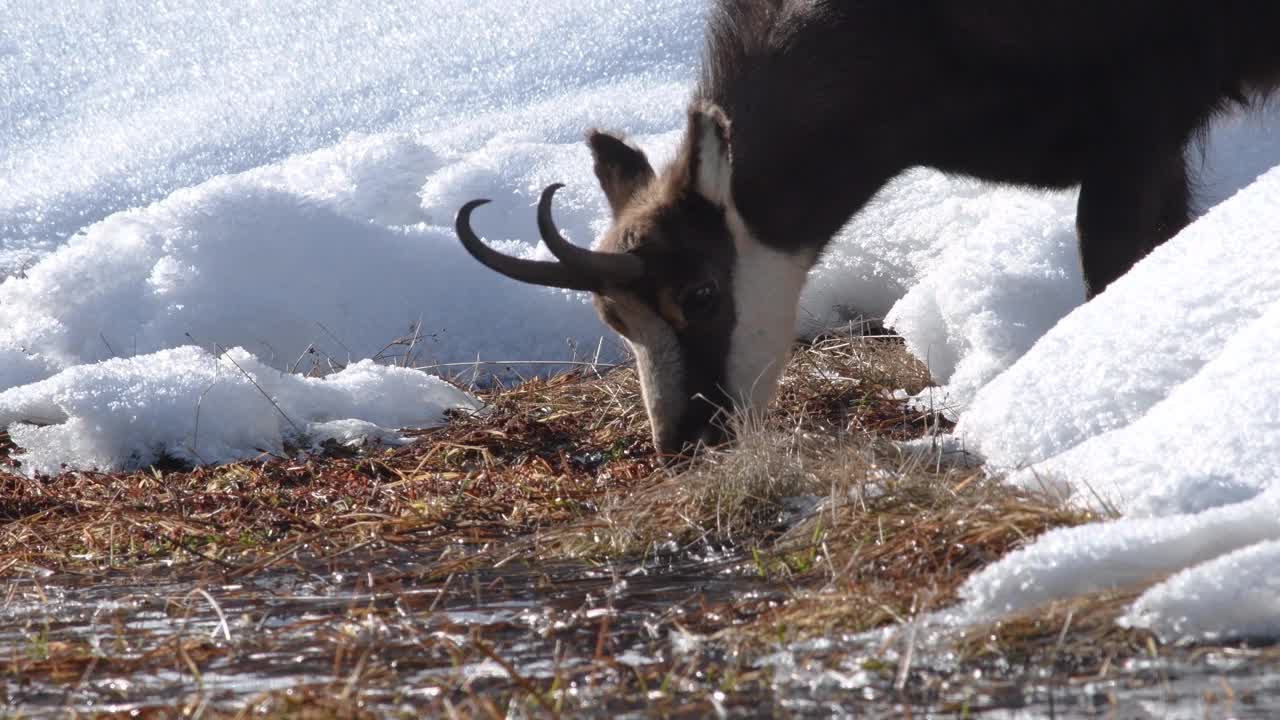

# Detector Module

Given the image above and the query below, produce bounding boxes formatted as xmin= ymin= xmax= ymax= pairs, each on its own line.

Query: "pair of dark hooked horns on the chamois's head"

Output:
xmin=453 ymin=183 xmax=644 ymax=292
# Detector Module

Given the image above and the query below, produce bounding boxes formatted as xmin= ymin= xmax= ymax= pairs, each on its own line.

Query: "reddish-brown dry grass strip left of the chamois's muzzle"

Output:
xmin=0 ymin=370 xmax=659 ymax=577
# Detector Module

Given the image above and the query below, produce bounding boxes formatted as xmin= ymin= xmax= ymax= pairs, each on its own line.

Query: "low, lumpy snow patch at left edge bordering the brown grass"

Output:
xmin=0 ymin=346 xmax=477 ymax=474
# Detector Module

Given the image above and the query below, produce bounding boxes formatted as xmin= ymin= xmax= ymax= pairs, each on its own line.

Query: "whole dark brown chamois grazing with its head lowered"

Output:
xmin=456 ymin=0 xmax=1280 ymax=454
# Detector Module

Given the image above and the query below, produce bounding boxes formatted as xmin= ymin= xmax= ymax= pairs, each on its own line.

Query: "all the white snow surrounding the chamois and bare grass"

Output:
xmin=0 ymin=0 xmax=1280 ymax=639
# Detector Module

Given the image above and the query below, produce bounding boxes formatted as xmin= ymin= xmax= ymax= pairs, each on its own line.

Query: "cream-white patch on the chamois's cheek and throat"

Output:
xmin=724 ymin=205 xmax=814 ymax=413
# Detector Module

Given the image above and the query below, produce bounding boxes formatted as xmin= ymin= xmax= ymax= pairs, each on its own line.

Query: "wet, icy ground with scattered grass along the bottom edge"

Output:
xmin=0 ymin=547 xmax=1280 ymax=717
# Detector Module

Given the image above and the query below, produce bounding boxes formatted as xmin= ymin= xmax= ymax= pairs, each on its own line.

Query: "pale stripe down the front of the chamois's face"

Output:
xmin=618 ymin=299 xmax=689 ymax=448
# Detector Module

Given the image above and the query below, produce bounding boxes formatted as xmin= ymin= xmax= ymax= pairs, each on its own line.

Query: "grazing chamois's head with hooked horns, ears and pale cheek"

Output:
xmin=456 ymin=105 xmax=808 ymax=454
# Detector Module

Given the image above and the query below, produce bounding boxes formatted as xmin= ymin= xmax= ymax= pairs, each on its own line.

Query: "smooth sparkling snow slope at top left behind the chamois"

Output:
xmin=0 ymin=0 xmax=703 ymax=275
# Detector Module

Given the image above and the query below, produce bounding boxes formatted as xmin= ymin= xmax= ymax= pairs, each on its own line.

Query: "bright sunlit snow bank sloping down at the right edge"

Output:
xmin=955 ymin=156 xmax=1280 ymax=639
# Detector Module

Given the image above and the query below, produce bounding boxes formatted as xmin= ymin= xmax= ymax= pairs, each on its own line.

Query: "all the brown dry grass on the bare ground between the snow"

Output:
xmin=0 ymin=336 xmax=1249 ymax=717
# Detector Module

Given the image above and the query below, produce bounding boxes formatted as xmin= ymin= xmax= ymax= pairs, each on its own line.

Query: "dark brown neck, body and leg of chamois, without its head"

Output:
xmin=675 ymin=0 xmax=1280 ymax=295
